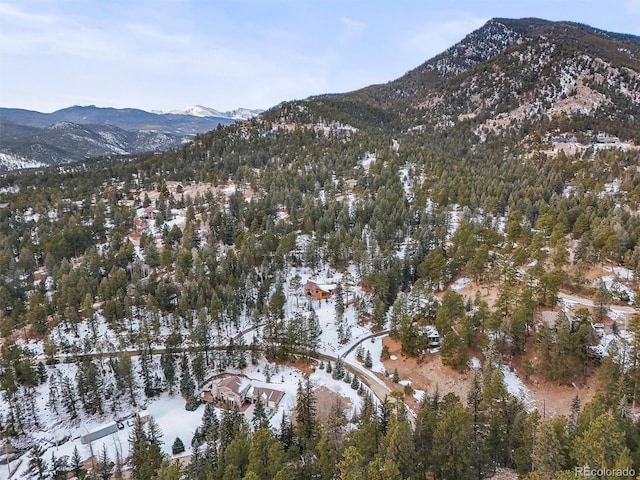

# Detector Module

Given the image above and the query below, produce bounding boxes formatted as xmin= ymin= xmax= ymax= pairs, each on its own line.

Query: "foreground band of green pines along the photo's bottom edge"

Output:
xmin=27 ymin=364 xmax=640 ymax=480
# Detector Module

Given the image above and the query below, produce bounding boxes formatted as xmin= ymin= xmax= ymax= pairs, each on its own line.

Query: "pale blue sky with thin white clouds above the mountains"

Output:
xmin=0 ymin=0 xmax=640 ymax=112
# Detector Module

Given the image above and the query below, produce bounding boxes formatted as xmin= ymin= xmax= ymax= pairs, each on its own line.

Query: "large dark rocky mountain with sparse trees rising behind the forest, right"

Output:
xmin=266 ymin=18 xmax=640 ymax=142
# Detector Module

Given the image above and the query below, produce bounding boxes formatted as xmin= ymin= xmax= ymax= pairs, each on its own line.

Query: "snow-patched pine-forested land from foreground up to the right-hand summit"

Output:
xmin=0 ymin=19 xmax=640 ymax=480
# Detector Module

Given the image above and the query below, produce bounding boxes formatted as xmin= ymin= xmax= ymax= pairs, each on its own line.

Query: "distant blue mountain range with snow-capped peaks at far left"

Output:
xmin=0 ymin=105 xmax=260 ymax=170
